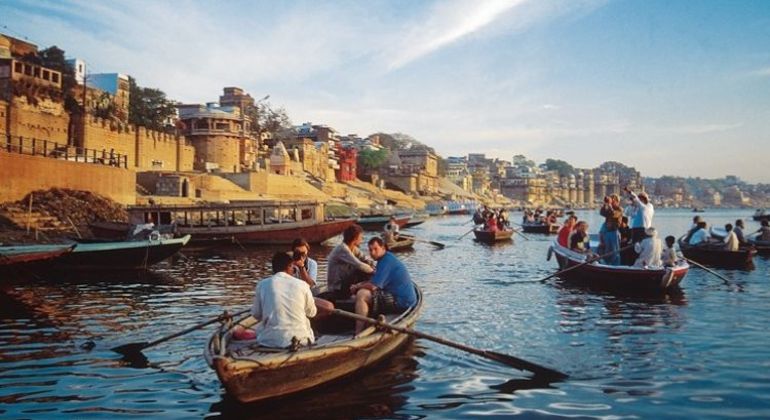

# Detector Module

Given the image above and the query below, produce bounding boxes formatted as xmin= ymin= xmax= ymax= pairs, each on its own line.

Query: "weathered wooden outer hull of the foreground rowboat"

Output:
xmin=206 ymin=286 xmax=422 ymax=402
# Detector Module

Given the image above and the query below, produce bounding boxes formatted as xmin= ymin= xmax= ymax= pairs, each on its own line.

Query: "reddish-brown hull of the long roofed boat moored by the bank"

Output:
xmin=91 ymin=219 xmax=355 ymax=245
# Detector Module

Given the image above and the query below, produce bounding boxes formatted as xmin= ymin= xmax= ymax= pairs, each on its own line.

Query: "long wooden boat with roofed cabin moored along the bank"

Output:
xmin=90 ymin=201 xmax=354 ymax=245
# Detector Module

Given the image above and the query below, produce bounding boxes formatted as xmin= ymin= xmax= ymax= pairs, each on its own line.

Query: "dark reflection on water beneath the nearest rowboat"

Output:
xmin=207 ymin=339 xmax=424 ymax=419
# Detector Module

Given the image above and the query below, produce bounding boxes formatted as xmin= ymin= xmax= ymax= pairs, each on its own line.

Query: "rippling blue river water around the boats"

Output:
xmin=0 ymin=210 xmax=770 ymax=419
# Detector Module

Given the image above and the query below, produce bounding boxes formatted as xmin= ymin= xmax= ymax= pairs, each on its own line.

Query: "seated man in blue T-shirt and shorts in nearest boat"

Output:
xmin=350 ymin=237 xmax=417 ymax=334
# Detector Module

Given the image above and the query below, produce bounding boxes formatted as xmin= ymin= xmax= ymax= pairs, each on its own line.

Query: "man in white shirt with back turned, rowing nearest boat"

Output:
xmin=251 ymin=252 xmax=328 ymax=348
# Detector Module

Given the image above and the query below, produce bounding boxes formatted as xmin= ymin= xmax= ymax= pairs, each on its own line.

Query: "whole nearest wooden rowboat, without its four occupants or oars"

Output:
xmin=204 ymin=286 xmax=423 ymax=402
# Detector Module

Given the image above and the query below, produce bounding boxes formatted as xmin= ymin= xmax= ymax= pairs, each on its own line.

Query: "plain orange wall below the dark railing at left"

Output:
xmin=0 ymin=151 xmax=136 ymax=204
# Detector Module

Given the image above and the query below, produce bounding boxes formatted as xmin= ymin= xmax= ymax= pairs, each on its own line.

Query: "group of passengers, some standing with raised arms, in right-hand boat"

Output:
xmin=557 ymin=187 xmax=679 ymax=268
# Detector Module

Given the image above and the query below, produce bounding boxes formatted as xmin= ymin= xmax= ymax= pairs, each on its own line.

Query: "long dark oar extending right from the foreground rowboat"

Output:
xmin=332 ymin=309 xmax=568 ymax=379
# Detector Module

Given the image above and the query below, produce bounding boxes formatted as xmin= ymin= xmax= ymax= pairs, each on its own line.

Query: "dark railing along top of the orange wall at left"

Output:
xmin=2 ymin=135 xmax=128 ymax=168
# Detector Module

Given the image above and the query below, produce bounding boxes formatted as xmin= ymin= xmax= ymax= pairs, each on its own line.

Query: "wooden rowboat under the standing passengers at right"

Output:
xmin=548 ymin=241 xmax=690 ymax=291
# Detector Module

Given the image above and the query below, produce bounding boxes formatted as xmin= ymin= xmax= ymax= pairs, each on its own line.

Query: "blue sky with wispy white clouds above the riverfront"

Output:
xmin=0 ymin=0 xmax=770 ymax=182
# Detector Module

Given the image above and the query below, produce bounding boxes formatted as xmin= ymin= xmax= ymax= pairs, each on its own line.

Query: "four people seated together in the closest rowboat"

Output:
xmin=243 ymin=225 xmax=417 ymax=348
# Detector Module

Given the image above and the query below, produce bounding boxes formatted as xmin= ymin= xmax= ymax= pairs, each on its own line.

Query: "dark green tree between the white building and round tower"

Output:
xmin=128 ymin=77 xmax=176 ymax=131
